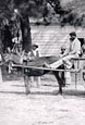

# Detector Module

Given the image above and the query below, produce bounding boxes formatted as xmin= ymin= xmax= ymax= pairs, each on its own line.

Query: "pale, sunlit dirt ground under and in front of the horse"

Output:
xmin=0 ymin=75 xmax=85 ymax=125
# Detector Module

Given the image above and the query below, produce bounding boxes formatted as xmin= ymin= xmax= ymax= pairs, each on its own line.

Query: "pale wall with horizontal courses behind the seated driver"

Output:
xmin=31 ymin=26 xmax=85 ymax=56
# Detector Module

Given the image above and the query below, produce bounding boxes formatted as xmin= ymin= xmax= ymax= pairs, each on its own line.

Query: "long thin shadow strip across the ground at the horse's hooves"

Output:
xmin=0 ymin=90 xmax=85 ymax=98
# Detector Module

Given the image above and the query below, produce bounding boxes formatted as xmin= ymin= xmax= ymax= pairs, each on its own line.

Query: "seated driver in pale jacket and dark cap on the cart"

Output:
xmin=61 ymin=32 xmax=81 ymax=68
